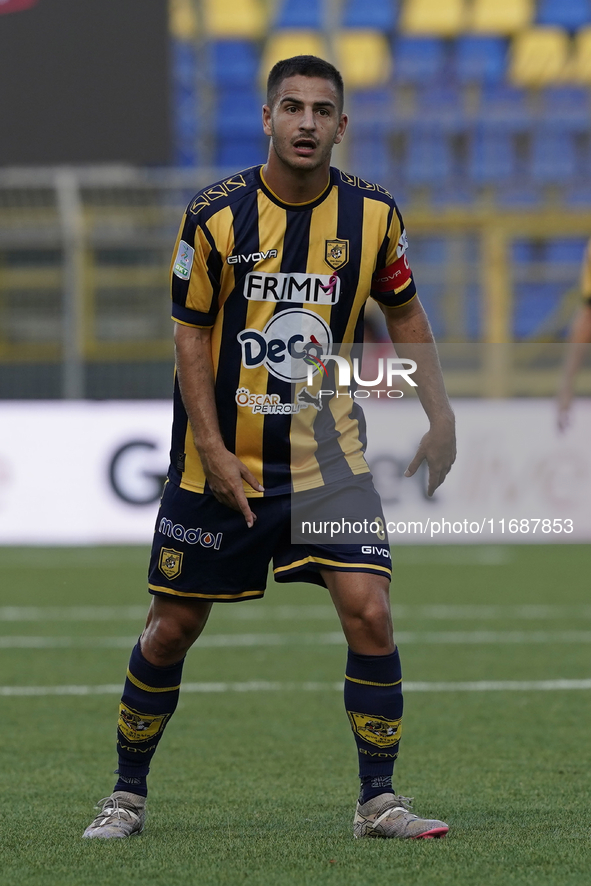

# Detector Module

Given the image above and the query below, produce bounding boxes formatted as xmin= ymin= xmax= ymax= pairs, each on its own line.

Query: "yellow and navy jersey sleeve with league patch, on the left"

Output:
xmin=170 ymin=213 xmax=221 ymax=326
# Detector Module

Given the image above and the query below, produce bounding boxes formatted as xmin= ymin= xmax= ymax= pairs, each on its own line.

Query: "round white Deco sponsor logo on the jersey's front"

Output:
xmin=237 ymin=308 xmax=332 ymax=382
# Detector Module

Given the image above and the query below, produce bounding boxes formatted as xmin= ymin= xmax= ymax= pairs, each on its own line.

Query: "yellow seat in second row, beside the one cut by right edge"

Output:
xmin=509 ymin=27 xmax=570 ymax=86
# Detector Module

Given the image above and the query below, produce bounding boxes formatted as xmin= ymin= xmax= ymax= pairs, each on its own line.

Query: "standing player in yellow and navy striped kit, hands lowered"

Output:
xmin=84 ymin=56 xmax=455 ymax=838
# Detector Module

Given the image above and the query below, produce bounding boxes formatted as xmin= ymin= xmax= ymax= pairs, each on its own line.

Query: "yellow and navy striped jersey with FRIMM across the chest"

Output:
xmin=169 ymin=167 xmax=415 ymax=496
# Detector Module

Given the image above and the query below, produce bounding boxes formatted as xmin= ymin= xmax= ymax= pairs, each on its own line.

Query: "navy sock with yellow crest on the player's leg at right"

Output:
xmin=345 ymin=649 xmax=402 ymax=803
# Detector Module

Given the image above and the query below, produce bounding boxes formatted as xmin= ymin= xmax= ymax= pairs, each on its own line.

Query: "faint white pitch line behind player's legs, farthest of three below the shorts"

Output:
xmin=0 ymin=600 xmax=591 ymax=623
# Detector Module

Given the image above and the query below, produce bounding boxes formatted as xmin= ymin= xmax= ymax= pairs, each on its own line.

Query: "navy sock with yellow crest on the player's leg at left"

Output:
xmin=113 ymin=640 xmax=184 ymax=797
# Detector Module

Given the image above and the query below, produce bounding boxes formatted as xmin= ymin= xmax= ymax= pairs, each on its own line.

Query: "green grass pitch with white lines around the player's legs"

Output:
xmin=0 ymin=545 xmax=591 ymax=886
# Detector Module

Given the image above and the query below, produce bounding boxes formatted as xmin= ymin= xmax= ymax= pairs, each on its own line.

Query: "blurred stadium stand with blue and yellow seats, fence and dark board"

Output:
xmin=0 ymin=0 xmax=591 ymax=400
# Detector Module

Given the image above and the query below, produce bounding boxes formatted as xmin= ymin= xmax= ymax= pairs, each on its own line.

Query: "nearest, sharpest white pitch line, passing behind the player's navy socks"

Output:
xmin=0 ymin=679 xmax=591 ymax=698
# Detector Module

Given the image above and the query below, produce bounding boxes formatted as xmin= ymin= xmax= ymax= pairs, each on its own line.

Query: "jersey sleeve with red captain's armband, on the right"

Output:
xmin=371 ymin=204 xmax=417 ymax=308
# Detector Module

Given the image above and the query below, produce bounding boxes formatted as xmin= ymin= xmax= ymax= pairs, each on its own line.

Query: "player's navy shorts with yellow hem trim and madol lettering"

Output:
xmin=148 ymin=474 xmax=392 ymax=601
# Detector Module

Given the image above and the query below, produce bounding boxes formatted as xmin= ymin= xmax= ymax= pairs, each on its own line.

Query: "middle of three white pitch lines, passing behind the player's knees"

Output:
xmin=0 ymin=631 xmax=591 ymax=649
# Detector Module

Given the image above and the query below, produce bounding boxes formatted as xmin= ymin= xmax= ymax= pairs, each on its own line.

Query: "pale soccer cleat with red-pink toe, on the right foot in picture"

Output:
xmin=353 ymin=794 xmax=449 ymax=840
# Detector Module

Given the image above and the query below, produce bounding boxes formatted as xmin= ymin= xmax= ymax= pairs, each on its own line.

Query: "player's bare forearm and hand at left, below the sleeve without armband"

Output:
xmin=174 ymin=323 xmax=263 ymax=528
